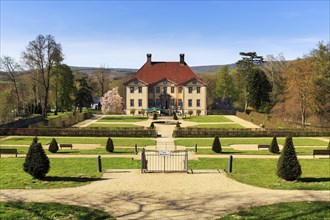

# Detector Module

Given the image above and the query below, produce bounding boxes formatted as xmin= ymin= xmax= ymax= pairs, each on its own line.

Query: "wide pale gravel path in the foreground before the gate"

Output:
xmin=0 ymin=170 xmax=330 ymax=219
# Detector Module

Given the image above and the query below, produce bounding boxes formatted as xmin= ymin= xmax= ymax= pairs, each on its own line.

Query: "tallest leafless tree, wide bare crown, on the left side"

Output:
xmin=22 ymin=35 xmax=63 ymax=118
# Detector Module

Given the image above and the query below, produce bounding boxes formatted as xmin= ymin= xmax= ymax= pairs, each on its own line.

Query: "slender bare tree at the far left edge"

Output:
xmin=0 ymin=56 xmax=21 ymax=113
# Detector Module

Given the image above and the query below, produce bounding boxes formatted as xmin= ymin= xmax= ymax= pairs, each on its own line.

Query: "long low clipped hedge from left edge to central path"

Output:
xmin=0 ymin=128 xmax=157 ymax=137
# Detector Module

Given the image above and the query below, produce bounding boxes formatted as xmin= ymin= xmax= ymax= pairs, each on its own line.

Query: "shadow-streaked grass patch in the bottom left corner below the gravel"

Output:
xmin=0 ymin=202 xmax=113 ymax=220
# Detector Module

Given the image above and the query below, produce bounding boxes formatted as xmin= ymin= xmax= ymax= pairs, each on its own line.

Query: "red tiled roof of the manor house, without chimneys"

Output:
xmin=128 ymin=62 xmax=203 ymax=84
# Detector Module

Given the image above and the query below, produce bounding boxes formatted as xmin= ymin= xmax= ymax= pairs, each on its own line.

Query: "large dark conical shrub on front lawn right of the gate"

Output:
xmin=277 ymin=136 xmax=301 ymax=181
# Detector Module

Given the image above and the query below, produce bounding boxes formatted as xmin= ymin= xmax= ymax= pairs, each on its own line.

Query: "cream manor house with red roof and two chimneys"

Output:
xmin=124 ymin=54 xmax=207 ymax=115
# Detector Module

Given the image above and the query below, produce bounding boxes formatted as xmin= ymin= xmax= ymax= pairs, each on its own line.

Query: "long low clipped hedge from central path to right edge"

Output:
xmin=173 ymin=128 xmax=330 ymax=137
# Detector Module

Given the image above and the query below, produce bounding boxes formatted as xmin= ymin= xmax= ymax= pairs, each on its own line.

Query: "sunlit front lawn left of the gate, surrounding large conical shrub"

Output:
xmin=0 ymin=157 xmax=140 ymax=189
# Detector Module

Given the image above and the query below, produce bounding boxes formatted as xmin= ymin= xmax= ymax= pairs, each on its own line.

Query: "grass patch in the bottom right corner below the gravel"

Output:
xmin=220 ymin=202 xmax=330 ymax=220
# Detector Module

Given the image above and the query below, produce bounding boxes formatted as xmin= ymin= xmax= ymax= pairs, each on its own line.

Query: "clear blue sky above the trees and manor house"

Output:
xmin=0 ymin=0 xmax=330 ymax=68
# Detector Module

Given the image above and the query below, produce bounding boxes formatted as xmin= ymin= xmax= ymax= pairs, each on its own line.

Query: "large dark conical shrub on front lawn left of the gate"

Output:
xmin=23 ymin=137 xmax=50 ymax=179
